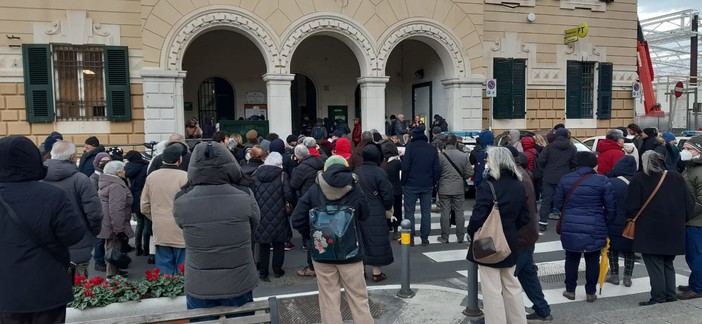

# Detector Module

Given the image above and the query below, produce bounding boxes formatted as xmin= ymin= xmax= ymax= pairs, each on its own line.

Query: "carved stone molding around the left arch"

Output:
xmin=160 ymin=6 xmax=278 ymax=71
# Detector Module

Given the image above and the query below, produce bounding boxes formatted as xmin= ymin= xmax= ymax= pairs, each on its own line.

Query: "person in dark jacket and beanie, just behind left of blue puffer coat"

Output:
xmin=538 ymin=128 xmax=576 ymax=232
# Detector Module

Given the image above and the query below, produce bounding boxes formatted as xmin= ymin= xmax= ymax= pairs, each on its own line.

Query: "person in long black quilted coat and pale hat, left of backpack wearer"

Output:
xmin=253 ymin=152 xmax=295 ymax=281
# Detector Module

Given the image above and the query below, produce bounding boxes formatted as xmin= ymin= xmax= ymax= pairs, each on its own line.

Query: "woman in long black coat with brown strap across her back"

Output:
xmin=626 ymin=150 xmax=695 ymax=306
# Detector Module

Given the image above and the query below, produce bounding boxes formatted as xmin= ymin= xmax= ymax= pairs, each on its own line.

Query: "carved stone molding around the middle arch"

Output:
xmin=279 ymin=14 xmax=376 ymax=76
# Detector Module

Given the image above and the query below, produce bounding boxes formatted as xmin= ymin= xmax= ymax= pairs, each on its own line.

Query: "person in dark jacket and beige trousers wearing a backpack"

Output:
xmin=291 ymin=155 xmax=373 ymax=324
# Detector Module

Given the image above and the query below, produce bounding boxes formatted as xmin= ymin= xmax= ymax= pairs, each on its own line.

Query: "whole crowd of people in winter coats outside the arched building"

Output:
xmin=0 ymin=115 xmax=702 ymax=323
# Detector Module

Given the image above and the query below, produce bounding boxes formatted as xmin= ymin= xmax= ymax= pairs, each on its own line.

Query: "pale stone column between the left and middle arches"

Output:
xmin=263 ymin=73 xmax=295 ymax=138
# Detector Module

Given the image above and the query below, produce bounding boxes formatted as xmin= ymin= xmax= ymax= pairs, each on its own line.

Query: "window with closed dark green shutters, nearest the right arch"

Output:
xmin=492 ymin=58 xmax=526 ymax=119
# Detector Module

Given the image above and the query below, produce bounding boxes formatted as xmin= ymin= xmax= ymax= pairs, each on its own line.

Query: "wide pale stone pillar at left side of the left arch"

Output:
xmin=141 ymin=70 xmax=186 ymax=142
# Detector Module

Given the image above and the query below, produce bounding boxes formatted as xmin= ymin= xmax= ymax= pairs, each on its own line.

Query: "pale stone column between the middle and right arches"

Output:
xmin=356 ymin=76 xmax=390 ymax=134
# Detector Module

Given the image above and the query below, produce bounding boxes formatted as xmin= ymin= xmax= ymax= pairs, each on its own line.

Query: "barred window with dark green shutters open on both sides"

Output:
xmin=22 ymin=44 xmax=131 ymax=122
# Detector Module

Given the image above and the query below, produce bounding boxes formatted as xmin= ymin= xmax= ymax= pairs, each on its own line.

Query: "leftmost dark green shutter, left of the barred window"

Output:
xmin=22 ymin=44 xmax=55 ymax=123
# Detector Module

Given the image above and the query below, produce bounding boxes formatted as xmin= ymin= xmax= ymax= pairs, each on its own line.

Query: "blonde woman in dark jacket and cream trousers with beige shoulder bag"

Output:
xmin=466 ymin=146 xmax=530 ymax=324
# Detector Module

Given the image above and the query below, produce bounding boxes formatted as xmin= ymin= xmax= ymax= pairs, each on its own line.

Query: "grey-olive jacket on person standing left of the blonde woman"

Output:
xmin=438 ymin=145 xmax=473 ymax=195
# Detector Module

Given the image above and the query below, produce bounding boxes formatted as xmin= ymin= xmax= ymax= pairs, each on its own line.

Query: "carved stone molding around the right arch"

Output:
xmin=377 ymin=19 xmax=470 ymax=78
